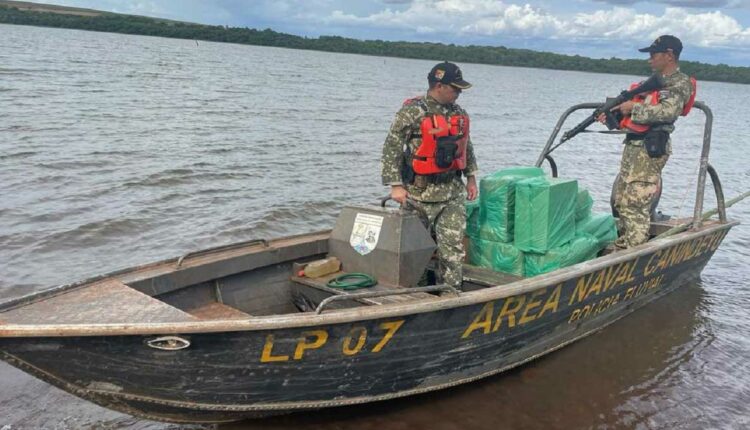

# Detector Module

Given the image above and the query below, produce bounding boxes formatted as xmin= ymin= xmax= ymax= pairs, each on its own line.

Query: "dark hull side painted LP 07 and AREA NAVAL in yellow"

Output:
xmin=0 ymin=225 xmax=731 ymax=422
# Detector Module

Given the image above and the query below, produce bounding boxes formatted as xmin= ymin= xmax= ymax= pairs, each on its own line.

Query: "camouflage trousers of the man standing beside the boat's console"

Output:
xmin=413 ymin=196 xmax=466 ymax=290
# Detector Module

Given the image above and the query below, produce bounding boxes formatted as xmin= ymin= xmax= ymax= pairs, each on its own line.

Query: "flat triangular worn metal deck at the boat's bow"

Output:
xmin=0 ymin=278 xmax=197 ymax=324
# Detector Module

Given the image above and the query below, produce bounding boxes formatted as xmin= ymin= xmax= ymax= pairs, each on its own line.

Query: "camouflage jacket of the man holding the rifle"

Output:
xmin=630 ymin=69 xmax=693 ymax=133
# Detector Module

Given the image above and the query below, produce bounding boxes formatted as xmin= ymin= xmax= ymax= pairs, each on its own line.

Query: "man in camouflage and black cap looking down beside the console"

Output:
xmin=382 ymin=61 xmax=478 ymax=290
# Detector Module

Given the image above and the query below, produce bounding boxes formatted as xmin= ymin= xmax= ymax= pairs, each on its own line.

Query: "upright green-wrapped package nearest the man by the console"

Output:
xmin=479 ymin=167 xmax=544 ymax=242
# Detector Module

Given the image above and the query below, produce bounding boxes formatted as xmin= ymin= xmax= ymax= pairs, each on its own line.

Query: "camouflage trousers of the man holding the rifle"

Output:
xmin=614 ymin=141 xmax=671 ymax=248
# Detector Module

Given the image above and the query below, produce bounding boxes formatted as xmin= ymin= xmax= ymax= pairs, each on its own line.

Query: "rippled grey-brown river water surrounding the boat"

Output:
xmin=0 ymin=25 xmax=750 ymax=430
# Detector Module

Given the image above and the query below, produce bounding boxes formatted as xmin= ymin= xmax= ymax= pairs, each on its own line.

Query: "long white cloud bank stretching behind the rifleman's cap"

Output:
xmin=324 ymin=0 xmax=750 ymax=49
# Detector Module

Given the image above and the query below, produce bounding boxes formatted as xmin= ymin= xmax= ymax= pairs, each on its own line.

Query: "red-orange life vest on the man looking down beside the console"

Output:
xmin=404 ymin=99 xmax=469 ymax=175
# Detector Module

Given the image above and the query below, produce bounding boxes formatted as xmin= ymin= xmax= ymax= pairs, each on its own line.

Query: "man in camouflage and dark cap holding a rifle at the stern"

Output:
xmin=614 ymin=35 xmax=693 ymax=248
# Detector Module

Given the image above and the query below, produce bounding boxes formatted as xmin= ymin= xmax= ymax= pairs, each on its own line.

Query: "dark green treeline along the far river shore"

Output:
xmin=0 ymin=4 xmax=750 ymax=84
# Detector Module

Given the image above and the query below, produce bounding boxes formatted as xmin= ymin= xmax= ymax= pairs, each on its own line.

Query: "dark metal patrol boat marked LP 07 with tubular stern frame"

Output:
xmin=0 ymin=102 xmax=738 ymax=423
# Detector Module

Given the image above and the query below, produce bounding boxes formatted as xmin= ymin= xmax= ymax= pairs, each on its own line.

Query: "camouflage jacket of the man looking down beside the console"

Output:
xmin=381 ymin=95 xmax=478 ymax=202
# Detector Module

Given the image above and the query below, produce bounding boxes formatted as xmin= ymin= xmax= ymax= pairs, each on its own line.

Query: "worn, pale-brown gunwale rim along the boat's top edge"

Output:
xmin=0 ymin=221 xmax=740 ymax=338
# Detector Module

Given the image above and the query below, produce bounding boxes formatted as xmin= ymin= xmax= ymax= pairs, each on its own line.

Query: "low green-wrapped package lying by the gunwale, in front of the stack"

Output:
xmin=523 ymin=234 xmax=603 ymax=276
